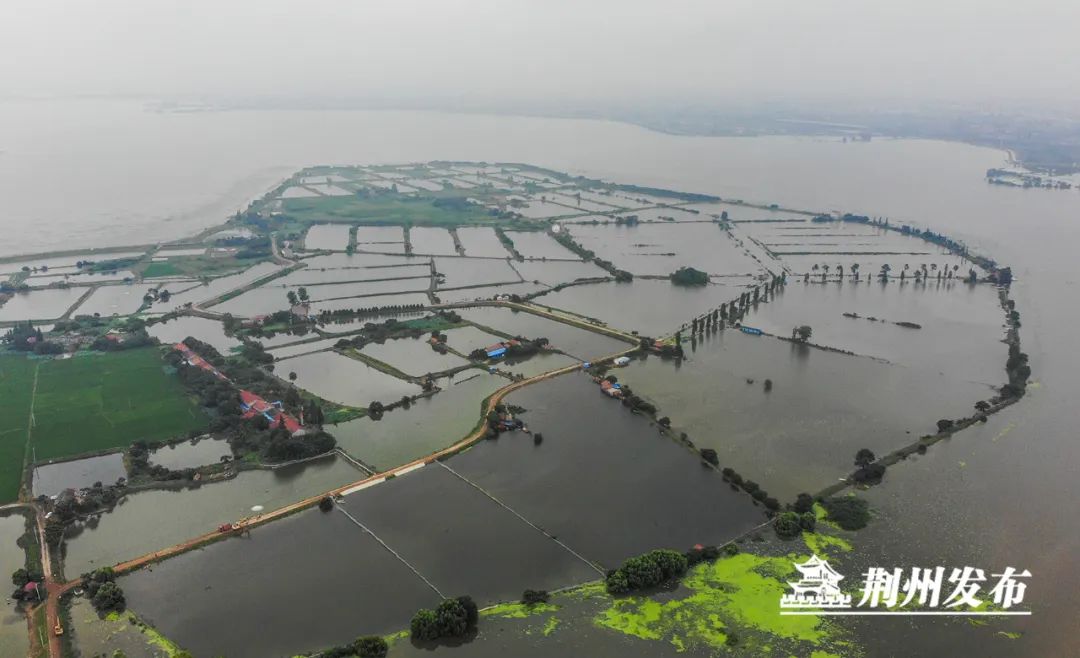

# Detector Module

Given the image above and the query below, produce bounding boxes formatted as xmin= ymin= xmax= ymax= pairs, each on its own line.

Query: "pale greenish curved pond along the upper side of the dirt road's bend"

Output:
xmin=332 ymin=371 xmax=509 ymax=470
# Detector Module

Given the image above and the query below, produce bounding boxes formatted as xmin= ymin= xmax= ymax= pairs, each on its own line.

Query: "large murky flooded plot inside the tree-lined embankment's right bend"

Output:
xmin=619 ymin=330 xmax=994 ymax=500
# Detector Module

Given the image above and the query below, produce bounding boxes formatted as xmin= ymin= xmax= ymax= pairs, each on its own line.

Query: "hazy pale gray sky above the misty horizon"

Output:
xmin=0 ymin=0 xmax=1080 ymax=105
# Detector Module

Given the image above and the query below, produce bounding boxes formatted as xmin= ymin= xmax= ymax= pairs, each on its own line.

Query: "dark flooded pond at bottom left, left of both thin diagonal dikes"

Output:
xmin=119 ymin=509 xmax=440 ymax=658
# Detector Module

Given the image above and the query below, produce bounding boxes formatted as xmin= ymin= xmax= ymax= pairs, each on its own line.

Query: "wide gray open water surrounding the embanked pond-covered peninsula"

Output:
xmin=0 ymin=100 xmax=1080 ymax=656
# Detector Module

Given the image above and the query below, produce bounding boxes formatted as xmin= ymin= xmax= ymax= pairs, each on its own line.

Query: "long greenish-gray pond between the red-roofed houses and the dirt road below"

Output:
xmin=64 ymin=457 xmax=364 ymax=577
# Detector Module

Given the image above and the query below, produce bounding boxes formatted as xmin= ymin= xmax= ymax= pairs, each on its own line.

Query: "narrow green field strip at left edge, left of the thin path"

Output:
xmin=0 ymin=354 xmax=38 ymax=502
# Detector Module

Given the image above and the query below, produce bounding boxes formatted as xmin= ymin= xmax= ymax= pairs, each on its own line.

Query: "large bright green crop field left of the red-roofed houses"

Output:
xmin=30 ymin=348 xmax=206 ymax=461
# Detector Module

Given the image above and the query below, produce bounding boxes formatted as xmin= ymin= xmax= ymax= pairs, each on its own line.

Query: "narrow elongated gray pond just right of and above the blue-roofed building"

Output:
xmin=458 ymin=308 xmax=630 ymax=361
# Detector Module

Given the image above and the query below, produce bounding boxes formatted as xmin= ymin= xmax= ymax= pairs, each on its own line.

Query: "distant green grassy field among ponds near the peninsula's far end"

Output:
xmin=284 ymin=196 xmax=496 ymax=226
